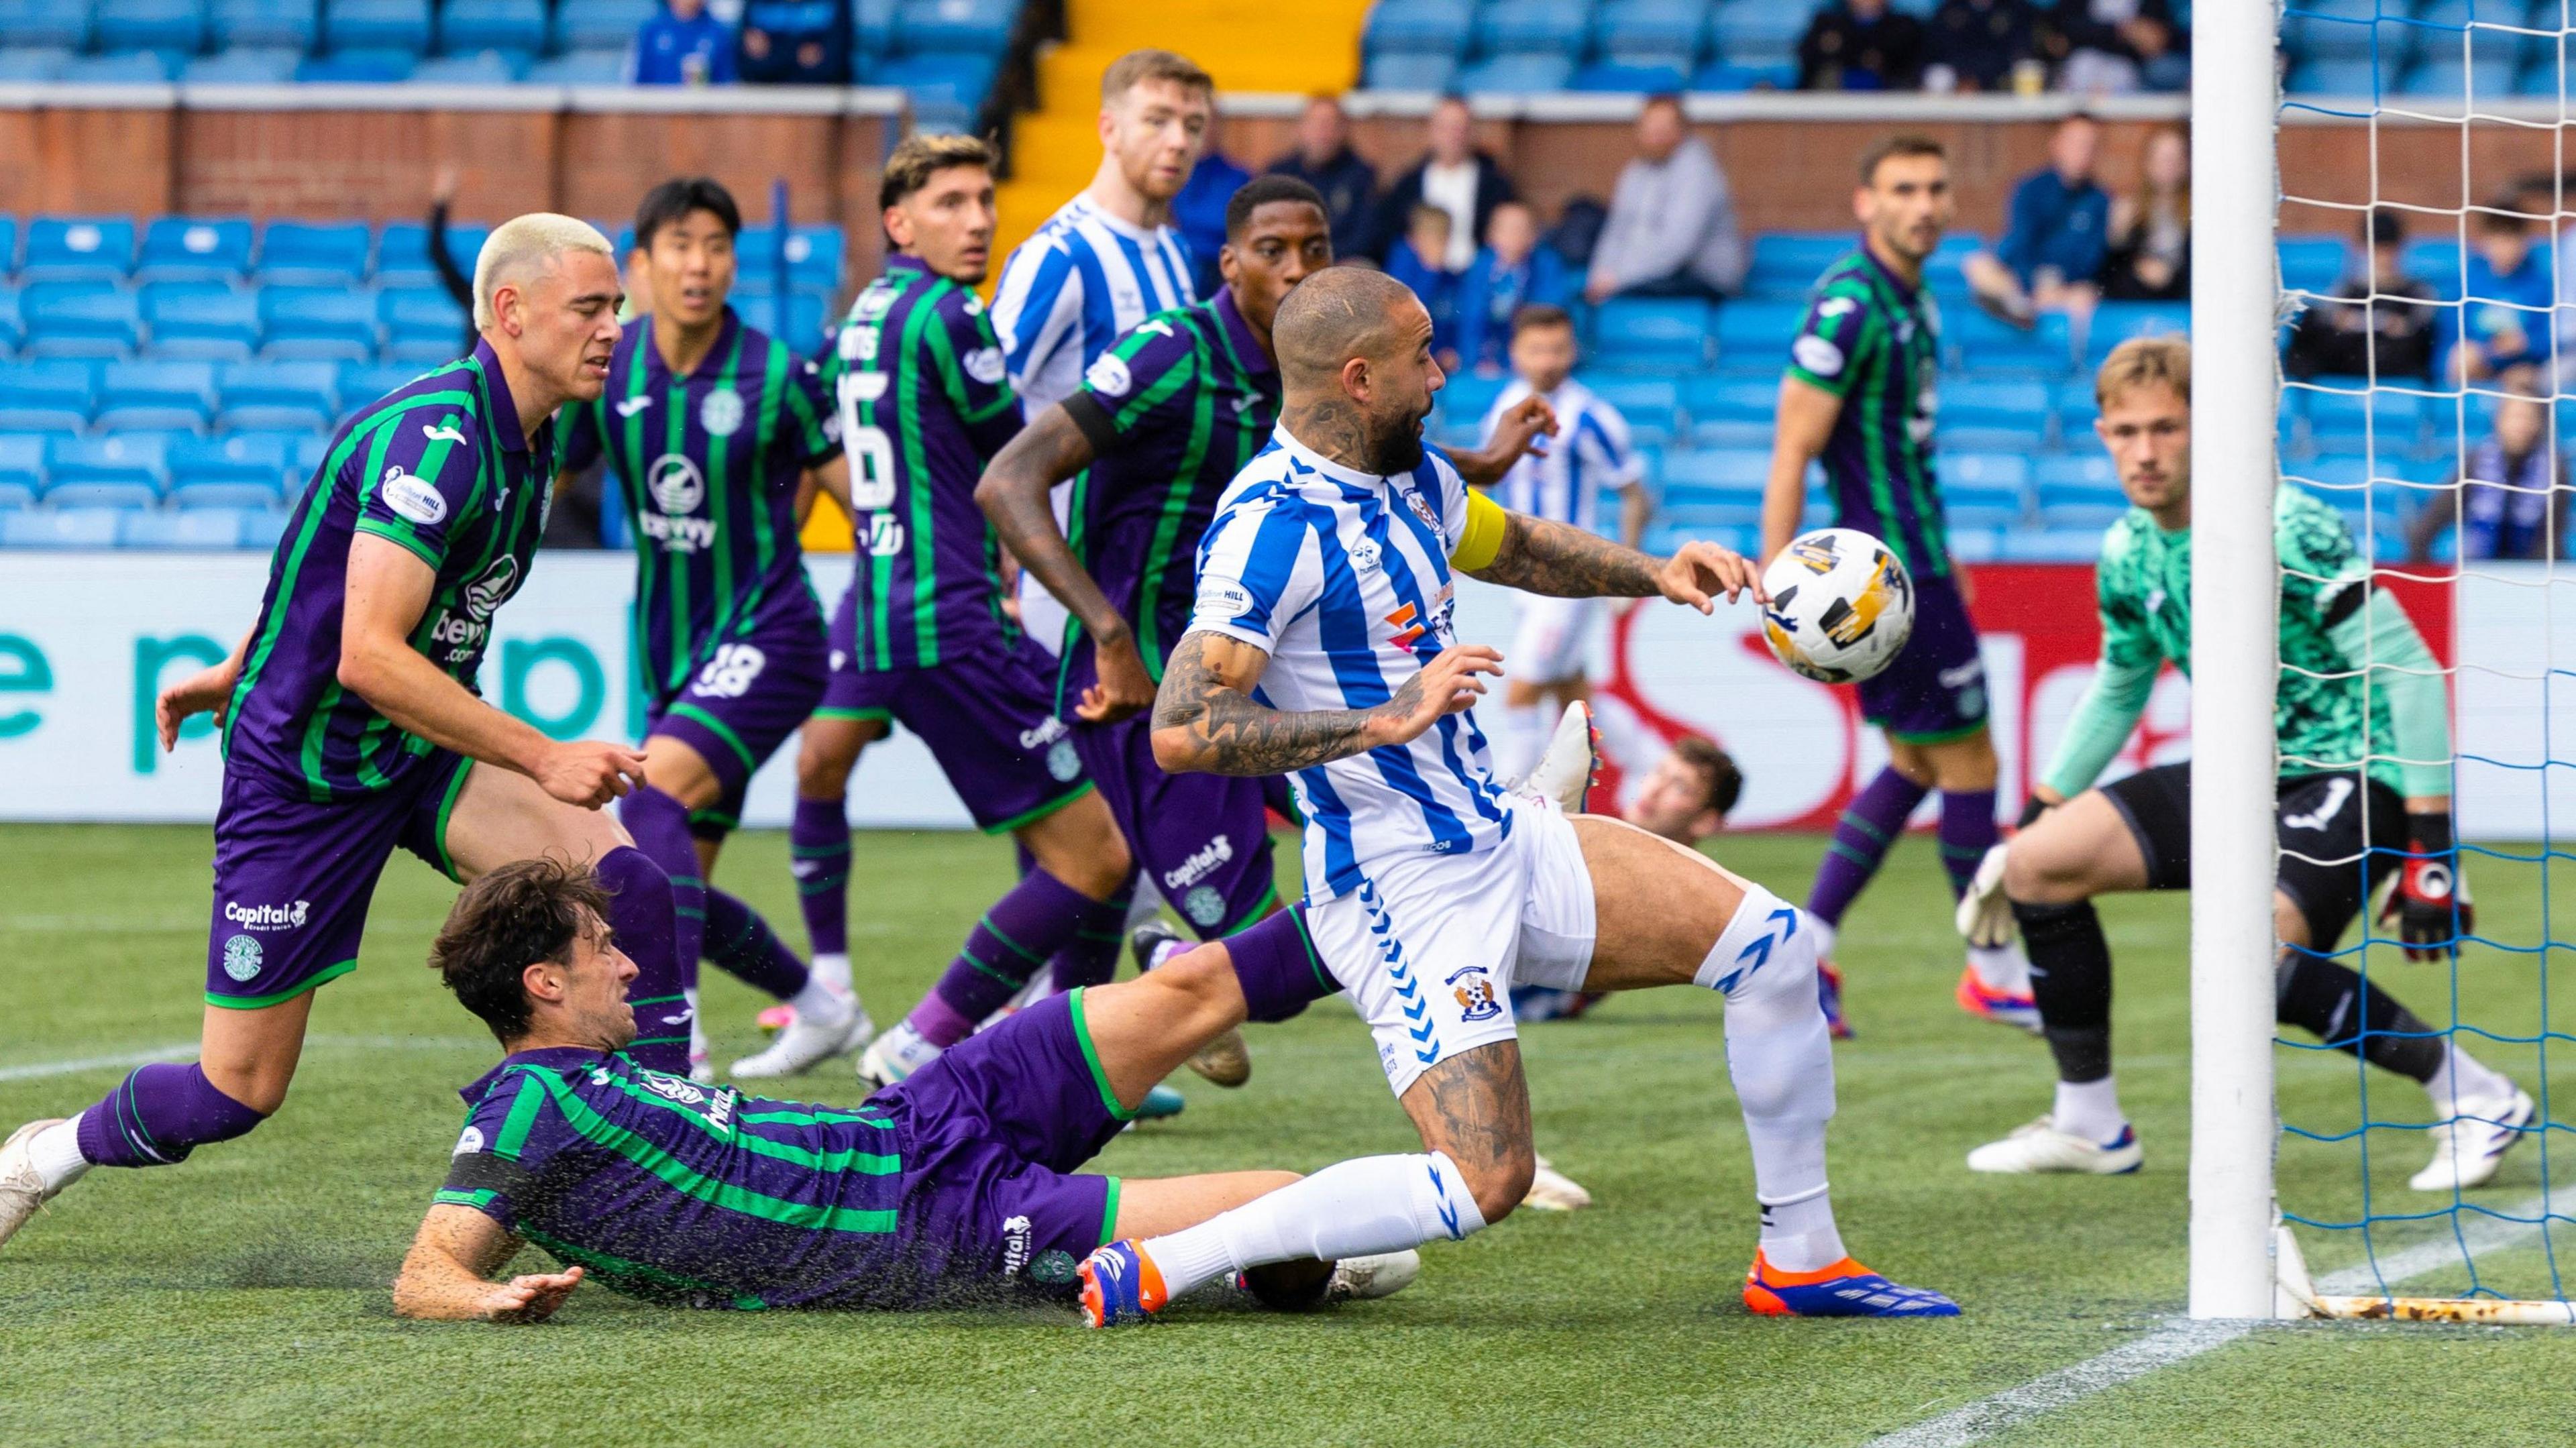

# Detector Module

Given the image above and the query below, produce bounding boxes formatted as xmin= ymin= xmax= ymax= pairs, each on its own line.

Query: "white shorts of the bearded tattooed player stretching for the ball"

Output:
xmin=1306 ymin=791 xmax=1595 ymax=1098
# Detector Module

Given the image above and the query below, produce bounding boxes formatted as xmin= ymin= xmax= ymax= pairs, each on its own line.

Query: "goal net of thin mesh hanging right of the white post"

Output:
xmin=2256 ymin=0 xmax=2576 ymax=1322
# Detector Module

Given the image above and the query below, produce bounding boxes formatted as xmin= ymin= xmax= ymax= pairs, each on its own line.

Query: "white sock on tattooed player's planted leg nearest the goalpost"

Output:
xmin=1693 ymin=887 xmax=1844 ymax=1273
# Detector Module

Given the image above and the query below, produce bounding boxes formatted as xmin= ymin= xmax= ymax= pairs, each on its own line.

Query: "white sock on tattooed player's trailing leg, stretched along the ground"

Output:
xmin=1136 ymin=1152 xmax=1484 ymax=1296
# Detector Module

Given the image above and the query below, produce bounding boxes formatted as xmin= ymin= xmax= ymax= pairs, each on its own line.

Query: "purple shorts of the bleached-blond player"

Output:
xmin=206 ymin=750 xmax=474 ymax=1010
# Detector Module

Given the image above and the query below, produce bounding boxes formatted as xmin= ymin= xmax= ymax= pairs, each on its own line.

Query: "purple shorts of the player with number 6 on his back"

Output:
xmin=814 ymin=613 xmax=1092 ymax=835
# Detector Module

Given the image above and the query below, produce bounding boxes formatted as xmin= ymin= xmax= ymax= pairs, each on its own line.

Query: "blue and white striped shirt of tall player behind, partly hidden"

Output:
xmin=991 ymin=196 xmax=1198 ymax=415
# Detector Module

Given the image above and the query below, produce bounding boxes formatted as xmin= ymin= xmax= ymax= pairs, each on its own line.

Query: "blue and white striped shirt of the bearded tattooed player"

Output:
xmin=1190 ymin=428 xmax=1512 ymax=899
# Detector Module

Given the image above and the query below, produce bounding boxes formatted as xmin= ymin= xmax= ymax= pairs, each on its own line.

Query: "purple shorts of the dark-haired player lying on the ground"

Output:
xmin=881 ymin=989 xmax=1134 ymax=1286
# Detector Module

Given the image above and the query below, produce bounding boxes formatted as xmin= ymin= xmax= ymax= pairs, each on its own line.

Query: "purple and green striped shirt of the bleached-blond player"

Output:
xmin=224 ymin=343 xmax=554 ymax=804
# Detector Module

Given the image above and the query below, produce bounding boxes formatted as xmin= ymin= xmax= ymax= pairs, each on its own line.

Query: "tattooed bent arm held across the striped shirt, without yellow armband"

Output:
xmin=1154 ymin=628 xmax=1502 ymax=778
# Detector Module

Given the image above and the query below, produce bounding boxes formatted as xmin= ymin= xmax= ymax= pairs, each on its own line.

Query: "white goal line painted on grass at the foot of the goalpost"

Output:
xmin=1870 ymin=1196 xmax=2551 ymax=1448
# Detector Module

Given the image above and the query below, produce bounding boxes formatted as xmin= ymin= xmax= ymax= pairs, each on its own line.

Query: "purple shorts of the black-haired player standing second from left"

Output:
xmin=644 ymin=618 xmax=829 ymax=840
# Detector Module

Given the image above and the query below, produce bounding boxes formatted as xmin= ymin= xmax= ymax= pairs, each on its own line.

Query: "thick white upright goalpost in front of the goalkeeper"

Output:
xmin=2190 ymin=0 xmax=2279 ymax=1317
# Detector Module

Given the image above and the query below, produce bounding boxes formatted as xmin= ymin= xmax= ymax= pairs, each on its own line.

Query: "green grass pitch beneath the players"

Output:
xmin=0 ymin=827 xmax=2576 ymax=1448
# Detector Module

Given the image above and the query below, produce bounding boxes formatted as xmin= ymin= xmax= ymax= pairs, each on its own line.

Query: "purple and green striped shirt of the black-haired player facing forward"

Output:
xmin=564 ymin=307 xmax=840 ymax=706
